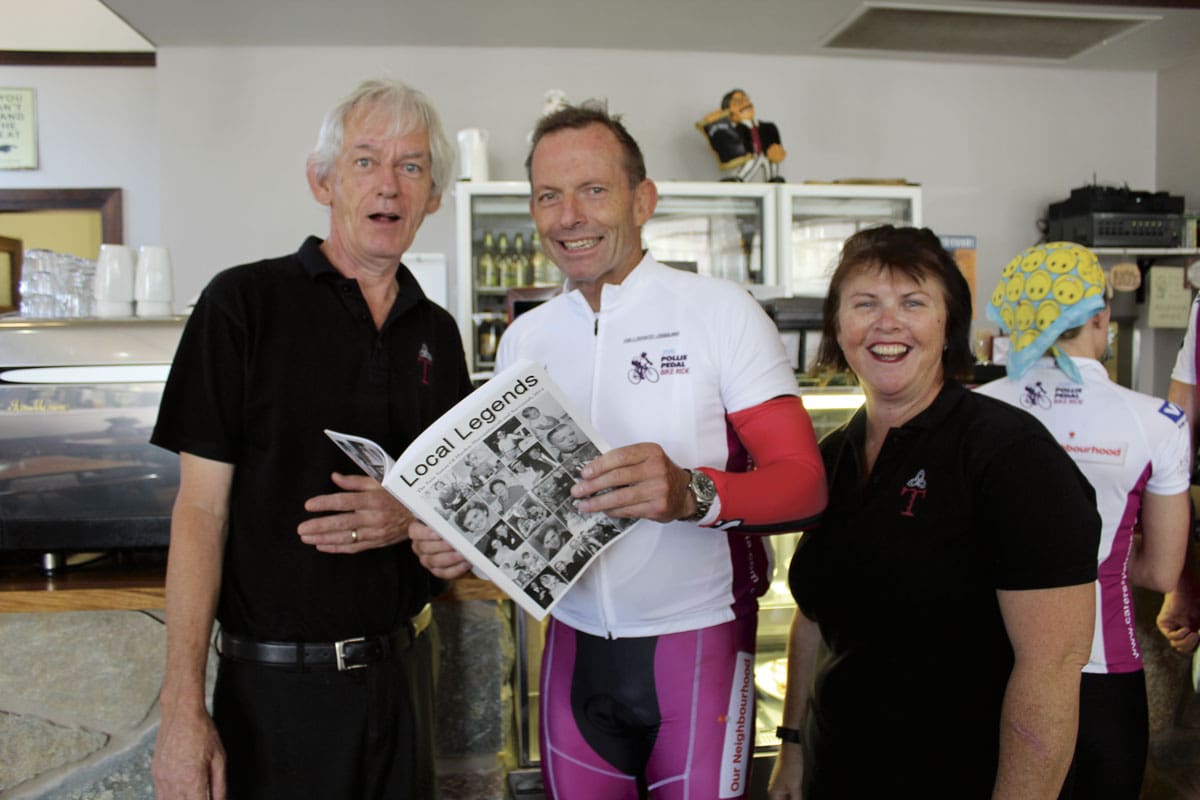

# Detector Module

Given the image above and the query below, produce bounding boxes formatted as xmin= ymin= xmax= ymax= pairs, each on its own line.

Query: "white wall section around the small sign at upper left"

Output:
xmin=0 ymin=66 xmax=162 ymax=250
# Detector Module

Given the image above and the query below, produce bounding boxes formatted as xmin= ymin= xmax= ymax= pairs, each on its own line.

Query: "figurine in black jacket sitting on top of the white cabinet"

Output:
xmin=696 ymin=89 xmax=787 ymax=184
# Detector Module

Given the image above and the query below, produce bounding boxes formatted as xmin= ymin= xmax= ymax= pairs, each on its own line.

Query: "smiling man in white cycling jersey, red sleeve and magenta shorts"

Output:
xmin=410 ymin=108 xmax=826 ymax=800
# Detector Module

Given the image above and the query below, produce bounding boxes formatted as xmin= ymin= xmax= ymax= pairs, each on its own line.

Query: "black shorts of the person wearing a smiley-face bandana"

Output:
xmin=1058 ymin=669 xmax=1150 ymax=800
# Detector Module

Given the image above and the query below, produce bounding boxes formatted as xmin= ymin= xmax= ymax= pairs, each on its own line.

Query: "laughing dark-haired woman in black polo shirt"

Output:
xmin=772 ymin=225 xmax=1099 ymax=799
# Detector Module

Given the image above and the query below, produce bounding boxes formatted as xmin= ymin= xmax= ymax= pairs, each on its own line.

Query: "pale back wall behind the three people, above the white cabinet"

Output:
xmin=150 ymin=48 xmax=1156 ymax=311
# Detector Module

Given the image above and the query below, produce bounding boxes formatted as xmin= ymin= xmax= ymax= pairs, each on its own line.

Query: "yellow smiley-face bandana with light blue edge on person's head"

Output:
xmin=988 ymin=241 xmax=1105 ymax=384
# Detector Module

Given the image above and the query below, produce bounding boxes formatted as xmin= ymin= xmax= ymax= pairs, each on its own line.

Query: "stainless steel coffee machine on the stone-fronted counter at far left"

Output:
xmin=0 ymin=315 xmax=185 ymax=571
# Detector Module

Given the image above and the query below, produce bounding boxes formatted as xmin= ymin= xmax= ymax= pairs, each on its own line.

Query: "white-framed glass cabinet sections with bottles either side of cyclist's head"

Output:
xmin=454 ymin=181 xmax=779 ymax=378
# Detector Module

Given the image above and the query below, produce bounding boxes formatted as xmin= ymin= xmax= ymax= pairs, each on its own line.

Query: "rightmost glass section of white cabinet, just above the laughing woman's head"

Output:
xmin=778 ymin=184 xmax=922 ymax=297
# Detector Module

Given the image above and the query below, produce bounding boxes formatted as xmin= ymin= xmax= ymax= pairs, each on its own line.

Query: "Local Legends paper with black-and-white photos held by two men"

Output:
xmin=325 ymin=361 xmax=636 ymax=620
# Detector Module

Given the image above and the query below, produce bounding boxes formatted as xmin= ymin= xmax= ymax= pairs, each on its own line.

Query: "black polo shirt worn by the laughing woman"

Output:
xmin=790 ymin=384 xmax=1100 ymax=800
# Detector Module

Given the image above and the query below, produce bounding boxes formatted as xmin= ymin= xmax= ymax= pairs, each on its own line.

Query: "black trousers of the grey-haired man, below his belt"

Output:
xmin=212 ymin=624 xmax=437 ymax=800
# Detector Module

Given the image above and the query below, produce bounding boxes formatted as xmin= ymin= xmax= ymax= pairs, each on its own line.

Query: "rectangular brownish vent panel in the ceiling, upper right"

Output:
xmin=824 ymin=4 xmax=1158 ymax=61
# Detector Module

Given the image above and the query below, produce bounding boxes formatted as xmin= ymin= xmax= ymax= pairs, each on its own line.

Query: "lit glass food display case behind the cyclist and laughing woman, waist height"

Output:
xmin=514 ymin=386 xmax=863 ymax=769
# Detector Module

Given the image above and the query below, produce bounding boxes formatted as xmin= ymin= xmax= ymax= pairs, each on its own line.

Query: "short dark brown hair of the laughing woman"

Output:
xmin=816 ymin=225 xmax=974 ymax=379
